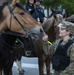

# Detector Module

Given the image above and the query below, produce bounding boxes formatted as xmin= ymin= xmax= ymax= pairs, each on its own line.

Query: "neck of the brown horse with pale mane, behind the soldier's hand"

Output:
xmin=42 ymin=16 xmax=55 ymax=42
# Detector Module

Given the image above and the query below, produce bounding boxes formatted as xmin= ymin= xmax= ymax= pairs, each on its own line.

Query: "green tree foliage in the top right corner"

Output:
xmin=42 ymin=0 xmax=74 ymax=15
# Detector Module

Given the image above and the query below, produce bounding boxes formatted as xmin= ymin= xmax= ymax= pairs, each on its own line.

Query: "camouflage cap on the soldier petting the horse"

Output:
xmin=58 ymin=21 xmax=74 ymax=35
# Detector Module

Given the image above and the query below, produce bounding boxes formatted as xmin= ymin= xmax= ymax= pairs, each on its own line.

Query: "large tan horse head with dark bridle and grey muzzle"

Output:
xmin=0 ymin=0 xmax=46 ymax=40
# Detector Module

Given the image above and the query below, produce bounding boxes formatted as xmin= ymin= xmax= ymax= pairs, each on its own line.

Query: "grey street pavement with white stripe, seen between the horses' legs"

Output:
xmin=12 ymin=57 xmax=53 ymax=75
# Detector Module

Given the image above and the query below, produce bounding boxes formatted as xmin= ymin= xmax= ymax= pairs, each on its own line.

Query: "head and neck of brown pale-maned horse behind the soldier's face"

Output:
xmin=42 ymin=13 xmax=64 ymax=42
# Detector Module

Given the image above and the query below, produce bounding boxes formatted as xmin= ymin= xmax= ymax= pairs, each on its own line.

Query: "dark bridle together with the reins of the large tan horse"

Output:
xmin=0 ymin=5 xmax=37 ymax=49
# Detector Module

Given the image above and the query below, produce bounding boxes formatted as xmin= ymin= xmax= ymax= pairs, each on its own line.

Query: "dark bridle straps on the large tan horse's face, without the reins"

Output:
xmin=8 ymin=5 xmax=38 ymax=39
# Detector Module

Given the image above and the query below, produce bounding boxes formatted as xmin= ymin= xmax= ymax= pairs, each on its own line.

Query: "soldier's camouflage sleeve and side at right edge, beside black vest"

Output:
xmin=60 ymin=41 xmax=74 ymax=75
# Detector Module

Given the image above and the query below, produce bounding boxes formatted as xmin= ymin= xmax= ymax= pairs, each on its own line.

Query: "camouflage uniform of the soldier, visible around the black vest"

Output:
xmin=49 ymin=40 xmax=74 ymax=75
